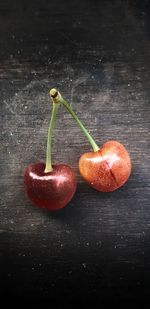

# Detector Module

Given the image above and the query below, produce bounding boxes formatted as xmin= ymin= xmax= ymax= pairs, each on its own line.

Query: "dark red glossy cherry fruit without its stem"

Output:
xmin=24 ymin=162 xmax=77 ymax=211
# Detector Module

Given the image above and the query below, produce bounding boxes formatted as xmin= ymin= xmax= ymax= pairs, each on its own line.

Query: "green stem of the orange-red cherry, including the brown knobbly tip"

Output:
xmin=50 ymin=89 xmax=99 ymax=152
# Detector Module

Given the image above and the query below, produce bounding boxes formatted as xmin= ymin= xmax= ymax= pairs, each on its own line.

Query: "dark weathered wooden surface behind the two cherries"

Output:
xmin=0 ymin=0 xmax=150 ymax=304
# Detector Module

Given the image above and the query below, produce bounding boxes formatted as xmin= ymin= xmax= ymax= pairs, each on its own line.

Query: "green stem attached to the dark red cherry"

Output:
xmin=44 ymin=102 xmax=59 ymax=173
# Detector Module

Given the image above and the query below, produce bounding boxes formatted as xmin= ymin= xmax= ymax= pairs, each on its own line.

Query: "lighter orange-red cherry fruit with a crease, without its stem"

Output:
xmin=79 ymin=140 xmax=131 ymax=192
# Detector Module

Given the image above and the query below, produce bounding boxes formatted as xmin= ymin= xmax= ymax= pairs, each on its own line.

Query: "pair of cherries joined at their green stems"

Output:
xmin=24 ymin=89 xmax=131 ymax=211
